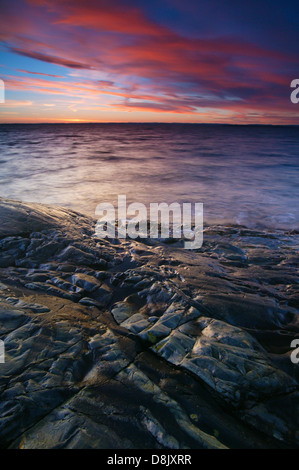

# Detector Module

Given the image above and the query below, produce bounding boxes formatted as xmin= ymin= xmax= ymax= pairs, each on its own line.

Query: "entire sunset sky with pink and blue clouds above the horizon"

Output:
xmin=0 ymin=0 xmax=299 ymax=124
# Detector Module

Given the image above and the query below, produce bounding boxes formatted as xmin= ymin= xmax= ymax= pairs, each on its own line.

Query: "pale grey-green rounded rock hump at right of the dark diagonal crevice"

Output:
xmin=176 ymin=319 xmax=296 ymax=405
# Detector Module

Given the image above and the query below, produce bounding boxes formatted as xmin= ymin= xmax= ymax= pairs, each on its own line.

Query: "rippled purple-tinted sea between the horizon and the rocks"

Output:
xmin=0 ymin=124 xmax=299 ymax=228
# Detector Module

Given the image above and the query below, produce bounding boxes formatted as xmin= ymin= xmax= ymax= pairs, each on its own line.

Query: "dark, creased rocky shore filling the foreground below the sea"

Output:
xmin=0 ymin=199 xmax=299 ymax=449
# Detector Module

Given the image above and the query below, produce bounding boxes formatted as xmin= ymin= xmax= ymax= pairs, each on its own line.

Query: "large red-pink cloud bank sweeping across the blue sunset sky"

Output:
xmin=0 ymin=0 xmax=297 ymax=123
